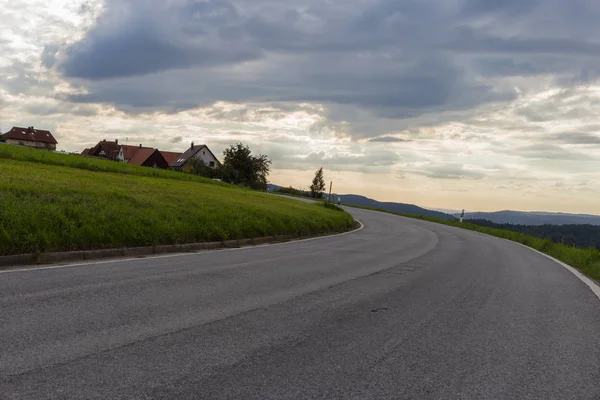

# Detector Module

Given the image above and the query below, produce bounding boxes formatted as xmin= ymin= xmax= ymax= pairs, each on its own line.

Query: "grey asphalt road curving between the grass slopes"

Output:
xmin=0 ymin=206 xmax=600 ymax=400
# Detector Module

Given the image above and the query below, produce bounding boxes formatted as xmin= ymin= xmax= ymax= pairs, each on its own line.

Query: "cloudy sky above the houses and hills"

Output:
xmin=0 ymin=0 xmax=600 ymax=213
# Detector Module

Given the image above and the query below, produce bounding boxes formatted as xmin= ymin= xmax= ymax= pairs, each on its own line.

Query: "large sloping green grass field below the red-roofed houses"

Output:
xmin=0 ymin=145 xmax=354 ymax=255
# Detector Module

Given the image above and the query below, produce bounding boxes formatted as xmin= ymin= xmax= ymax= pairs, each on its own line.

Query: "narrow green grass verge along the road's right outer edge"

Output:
xmin=348 ymin=205 xmax=600 ymax=280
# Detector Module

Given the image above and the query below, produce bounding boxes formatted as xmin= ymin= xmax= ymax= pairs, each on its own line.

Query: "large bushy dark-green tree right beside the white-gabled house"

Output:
xmin=221 ymin=143 xmax=271 ymax=190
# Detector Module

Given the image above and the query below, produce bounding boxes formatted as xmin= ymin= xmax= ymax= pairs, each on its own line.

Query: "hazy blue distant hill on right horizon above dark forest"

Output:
xmin=454 ymin=211 xmax=600 ymax=225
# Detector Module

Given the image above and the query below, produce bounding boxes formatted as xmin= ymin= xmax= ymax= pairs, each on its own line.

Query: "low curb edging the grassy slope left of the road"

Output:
xmin=0 ymin=220 xmax=364 ymax=270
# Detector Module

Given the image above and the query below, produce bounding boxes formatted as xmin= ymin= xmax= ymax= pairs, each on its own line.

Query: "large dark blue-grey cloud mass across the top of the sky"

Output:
xmin=60 ymin=0 xmax=600 ymax=137
